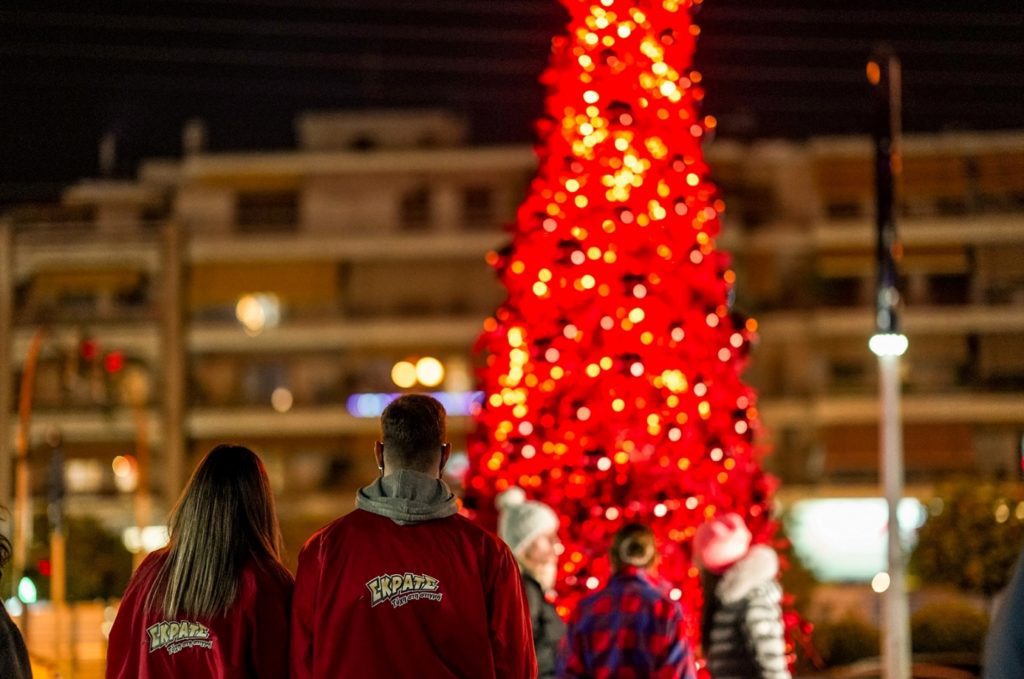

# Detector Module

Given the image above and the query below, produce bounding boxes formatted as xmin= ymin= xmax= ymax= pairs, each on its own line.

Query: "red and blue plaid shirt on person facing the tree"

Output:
xmin=558 ymin=566 xmax=696 ymax=679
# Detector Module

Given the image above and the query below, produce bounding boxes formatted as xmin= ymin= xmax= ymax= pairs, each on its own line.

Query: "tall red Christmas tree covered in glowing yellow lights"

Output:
xmin=467 ymin=0 xmax=786 ymax=655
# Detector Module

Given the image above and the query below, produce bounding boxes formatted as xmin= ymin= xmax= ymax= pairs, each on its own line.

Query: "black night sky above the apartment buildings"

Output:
xmin=0 ymin=0 xmax=1024 ymax=203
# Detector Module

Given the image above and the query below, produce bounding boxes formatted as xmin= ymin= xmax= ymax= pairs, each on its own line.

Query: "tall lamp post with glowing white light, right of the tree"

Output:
xmin=867 ymin=51 xmax=910 ymax=679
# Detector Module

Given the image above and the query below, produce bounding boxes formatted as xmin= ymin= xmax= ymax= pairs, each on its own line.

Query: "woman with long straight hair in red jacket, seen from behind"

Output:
xmin=106 ymin=444 xmax=293 ymax=679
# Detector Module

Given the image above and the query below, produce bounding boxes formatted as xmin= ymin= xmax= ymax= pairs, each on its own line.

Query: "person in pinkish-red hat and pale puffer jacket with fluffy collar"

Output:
xmin=693 ymin=513 xmax=791 ymax=679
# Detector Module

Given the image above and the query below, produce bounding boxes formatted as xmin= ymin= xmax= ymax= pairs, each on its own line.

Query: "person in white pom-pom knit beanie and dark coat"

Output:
xmin=495 ymin=486 xmax=565 ymax=679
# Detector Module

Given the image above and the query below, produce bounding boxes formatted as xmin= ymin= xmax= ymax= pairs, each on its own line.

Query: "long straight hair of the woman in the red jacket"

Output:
xmin=146 ymin=444 xmax=282 ymax=618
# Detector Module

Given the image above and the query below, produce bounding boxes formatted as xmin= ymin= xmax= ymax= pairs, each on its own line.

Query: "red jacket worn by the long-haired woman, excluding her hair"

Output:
xmin=106 ymin=550 xmax=292 ymax=679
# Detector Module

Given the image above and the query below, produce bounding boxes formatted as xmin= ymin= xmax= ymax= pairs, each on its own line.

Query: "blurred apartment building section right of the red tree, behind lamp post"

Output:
xmin=713 ymin=132 xmax=1024 ymax=495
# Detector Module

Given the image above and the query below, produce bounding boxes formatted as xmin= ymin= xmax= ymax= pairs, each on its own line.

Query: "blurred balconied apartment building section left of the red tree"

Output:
xmin=0 ymin=112 xmax=535 ymax=556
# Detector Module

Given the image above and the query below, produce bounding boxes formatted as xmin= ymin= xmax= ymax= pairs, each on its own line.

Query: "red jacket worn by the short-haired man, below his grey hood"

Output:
xmin=292 ymin=509 xmax=537 ymax=679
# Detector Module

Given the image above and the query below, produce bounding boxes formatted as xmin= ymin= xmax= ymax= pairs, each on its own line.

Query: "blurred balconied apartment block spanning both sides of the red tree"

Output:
xmin=0 ymin=112 xmax=1024 ymax=556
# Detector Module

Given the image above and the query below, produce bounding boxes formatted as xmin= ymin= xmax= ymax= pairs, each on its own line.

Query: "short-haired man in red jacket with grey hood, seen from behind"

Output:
xmin=292 ymin=394 xmax=537 ymax=679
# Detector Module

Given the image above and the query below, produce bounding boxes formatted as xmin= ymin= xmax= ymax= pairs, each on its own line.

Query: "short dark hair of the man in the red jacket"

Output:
xmin=381 ymin=393 xmax=447 ymax=471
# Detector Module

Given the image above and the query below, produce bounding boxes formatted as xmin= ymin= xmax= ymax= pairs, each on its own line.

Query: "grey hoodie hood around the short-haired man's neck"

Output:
xmin=355 ymin=469 xmax=459 ymax=525
